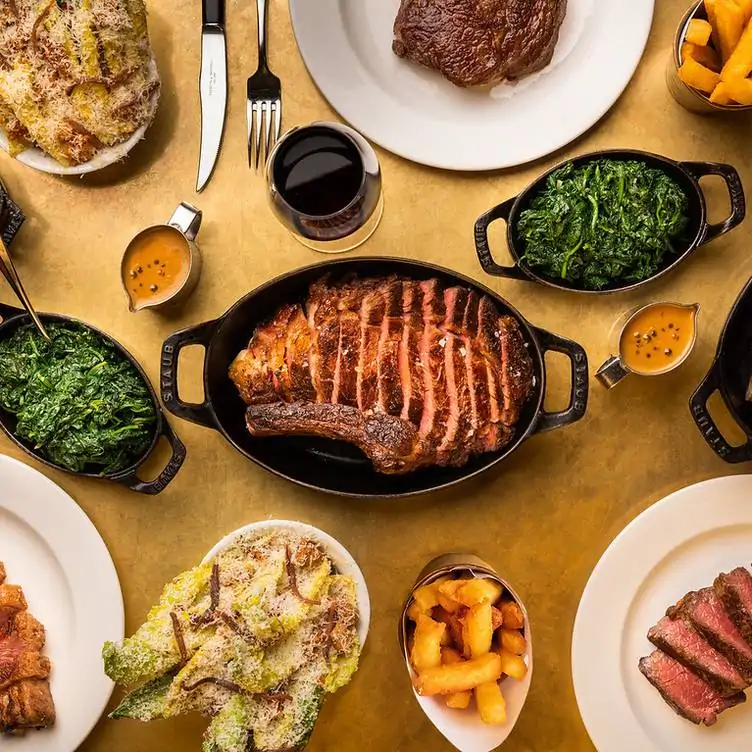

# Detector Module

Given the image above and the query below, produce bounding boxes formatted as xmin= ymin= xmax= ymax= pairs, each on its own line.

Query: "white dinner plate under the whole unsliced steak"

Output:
xmin=290 ymin=0 xmax=654 ymax=170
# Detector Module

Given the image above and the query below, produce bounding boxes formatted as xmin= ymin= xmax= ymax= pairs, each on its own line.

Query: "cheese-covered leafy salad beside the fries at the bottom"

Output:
xmin=103 ymin=530 xmax=360 ymax=752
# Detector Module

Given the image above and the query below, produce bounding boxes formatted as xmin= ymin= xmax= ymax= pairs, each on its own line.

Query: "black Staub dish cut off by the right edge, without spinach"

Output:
xmin=689 ymin=279 xmax=752 ymax=463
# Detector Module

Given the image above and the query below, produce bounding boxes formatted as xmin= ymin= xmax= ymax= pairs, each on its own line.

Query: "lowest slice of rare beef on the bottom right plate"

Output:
xmin=639 ymin=650 xmax=747 ymax=726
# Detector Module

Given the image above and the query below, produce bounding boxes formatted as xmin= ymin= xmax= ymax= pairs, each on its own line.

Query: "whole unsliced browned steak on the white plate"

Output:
xmin=392 ymin=0 xmax=567 ymax=87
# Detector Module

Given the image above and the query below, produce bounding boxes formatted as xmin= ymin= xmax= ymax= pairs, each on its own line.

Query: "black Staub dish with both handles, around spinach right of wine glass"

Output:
xmin=475 ymin=149 xmax=746 ymax=295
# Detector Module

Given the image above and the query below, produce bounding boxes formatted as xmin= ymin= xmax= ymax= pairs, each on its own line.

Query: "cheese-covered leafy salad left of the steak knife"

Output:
xmin=0 ymin=0 xmax=160 ymax=165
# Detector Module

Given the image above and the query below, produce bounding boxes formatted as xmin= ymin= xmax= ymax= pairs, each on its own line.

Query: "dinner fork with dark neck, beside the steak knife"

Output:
xmin=246 ymin=0 xmax=282 ymax=170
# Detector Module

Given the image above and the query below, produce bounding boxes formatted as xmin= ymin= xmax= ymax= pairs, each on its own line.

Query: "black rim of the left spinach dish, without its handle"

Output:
xmin=0 ymin=306 xmax=165 ymax=482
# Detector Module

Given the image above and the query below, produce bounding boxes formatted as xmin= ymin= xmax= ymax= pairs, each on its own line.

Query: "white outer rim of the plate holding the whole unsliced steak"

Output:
xmin=289 ymin=0 xmax=655 ymax=172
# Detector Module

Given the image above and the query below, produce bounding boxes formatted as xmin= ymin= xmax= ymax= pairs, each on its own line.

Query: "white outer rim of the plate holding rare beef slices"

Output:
xmin=571 ymin=475 xmax=752 ymax=752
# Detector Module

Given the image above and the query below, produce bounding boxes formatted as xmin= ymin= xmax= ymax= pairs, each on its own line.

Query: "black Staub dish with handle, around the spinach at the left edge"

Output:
xmin=0 ymin=303 xmax=186 ymax=496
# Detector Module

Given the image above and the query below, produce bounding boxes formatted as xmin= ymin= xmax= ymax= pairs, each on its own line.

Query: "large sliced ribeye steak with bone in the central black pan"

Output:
xmin=230 ymin=276 xmax=534 ymax=473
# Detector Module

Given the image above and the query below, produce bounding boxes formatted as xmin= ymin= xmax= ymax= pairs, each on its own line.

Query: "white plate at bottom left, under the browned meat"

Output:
xmin=0 ymin=455 xmax=124 ymax=752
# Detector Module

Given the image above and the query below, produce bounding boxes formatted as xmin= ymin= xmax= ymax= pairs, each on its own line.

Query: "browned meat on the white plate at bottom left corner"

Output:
xmin=0 ymin=562 xmax=55 ymax=734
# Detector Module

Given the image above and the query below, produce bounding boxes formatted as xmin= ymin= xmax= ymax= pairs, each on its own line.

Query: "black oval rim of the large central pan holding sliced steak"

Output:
xmin=191 ymin=256 xmax=560 ymax=500
